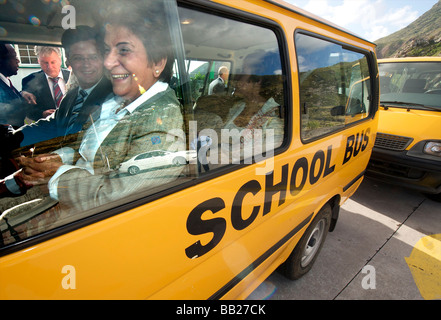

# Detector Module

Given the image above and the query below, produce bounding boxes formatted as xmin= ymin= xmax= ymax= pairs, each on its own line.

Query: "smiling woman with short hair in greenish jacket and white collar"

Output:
xmin=40 ymin=2 xmax=185 ymax=210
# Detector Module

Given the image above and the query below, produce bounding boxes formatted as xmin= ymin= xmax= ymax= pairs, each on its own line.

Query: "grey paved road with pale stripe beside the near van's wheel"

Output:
xmin=249 ymin=179 xmax=441 ymax=300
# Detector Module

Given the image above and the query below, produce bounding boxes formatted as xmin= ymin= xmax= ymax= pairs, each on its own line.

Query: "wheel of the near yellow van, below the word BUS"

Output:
xmin=281 ymin=204 xmax=332 ymax=280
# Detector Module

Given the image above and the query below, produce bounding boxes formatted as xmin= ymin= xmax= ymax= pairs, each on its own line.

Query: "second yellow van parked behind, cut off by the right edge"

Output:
xmin=368 ymin=57 xmax=441 ymax=201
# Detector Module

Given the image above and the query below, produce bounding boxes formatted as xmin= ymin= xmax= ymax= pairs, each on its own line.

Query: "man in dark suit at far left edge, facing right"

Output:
xmin=0 ymin=43 xmax=26 ymax=127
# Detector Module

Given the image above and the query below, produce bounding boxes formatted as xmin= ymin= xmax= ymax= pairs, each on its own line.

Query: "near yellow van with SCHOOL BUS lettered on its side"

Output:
xmin=0 ymin=0 xmax=379 ymax=299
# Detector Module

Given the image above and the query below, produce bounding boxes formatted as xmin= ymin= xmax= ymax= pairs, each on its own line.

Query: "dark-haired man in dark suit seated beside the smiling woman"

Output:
xmin=0 ymin=26 xmax=113 ymax=196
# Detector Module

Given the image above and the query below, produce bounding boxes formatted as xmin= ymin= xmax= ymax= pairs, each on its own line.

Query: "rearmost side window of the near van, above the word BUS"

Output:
xmin=295 ymin=33 xmax=371 ymax=141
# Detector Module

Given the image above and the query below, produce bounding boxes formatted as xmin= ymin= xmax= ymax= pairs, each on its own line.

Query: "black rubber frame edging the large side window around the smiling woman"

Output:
xmin=0 ymin=0 xmax=293 ymax=257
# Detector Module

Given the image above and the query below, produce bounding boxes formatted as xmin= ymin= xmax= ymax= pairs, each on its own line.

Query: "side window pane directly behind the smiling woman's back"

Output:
xmin=179 ymin=7 xmax=285 ymax=170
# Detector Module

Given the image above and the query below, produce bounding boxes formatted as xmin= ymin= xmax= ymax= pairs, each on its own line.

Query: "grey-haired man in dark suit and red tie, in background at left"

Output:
xmin=22 ymin=46 xmax=70 ymax=121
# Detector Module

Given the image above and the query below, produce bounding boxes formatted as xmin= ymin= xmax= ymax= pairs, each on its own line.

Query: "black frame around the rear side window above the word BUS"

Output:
xmin=294 ymin=28 xmax=379 ymax=145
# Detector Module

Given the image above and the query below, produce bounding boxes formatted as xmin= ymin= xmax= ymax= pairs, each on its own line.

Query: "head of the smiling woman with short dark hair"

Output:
xmin=104 ymin=3 xmax=174 ymax=101
